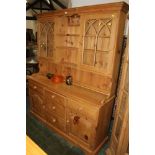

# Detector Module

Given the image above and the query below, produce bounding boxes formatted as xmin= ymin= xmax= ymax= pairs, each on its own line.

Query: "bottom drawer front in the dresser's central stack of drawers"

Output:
xmin=46 ymin=113 xmax=66 ymax=131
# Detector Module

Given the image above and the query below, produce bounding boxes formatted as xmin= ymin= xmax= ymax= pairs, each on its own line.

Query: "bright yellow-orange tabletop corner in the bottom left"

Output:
xmin=26 ymin=136 xmax=47 ymax=155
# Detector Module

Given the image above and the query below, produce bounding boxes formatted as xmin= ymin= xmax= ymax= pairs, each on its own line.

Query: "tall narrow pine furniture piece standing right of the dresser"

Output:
xmin=109 ymin=34 xmax=129 ymax=155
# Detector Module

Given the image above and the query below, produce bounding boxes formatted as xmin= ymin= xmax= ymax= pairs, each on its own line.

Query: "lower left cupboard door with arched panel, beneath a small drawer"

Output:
xmin=29 ymin=89 xmax=45 ymax=119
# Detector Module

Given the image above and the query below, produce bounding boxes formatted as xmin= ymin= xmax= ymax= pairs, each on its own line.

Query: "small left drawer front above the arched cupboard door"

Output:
xmin=29 ymin=80 xmax=44 ymax=95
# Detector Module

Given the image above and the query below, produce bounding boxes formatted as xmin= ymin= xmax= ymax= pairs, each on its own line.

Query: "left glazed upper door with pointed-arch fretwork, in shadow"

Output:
xmin=38 ymin=21 xmax=54 ymax=57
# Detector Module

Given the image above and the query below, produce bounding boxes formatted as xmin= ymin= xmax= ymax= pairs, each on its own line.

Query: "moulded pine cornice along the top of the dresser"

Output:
xmin=37 ymin=2 xmax=129 ymax=18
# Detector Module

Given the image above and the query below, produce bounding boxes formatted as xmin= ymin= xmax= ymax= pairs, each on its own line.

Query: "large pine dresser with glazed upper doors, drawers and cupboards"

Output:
xmin=29 ymin=2 xmax=128 ymax=155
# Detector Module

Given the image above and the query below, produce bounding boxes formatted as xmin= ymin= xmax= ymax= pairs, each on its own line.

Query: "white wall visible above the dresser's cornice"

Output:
xmin=72 ymin=0 xmax=129 ymax=7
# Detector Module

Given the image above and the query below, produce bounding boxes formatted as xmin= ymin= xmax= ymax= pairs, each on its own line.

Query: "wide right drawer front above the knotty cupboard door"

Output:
xmin=67 ymin=99 xmax=99 ymax=121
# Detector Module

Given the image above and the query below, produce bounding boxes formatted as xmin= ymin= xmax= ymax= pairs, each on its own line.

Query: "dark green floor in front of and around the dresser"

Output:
xmin=26 ymin=96 xmax=110 ymax=155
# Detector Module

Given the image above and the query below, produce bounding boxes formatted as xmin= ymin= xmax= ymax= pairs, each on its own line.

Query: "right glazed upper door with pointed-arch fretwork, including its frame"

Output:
xmin=82 ymin=14 xmax=118 ymax=74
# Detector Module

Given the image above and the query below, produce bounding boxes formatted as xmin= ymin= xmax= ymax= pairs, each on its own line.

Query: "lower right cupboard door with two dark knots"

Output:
xmin=67 ymin=111 xmax=94 ymax=144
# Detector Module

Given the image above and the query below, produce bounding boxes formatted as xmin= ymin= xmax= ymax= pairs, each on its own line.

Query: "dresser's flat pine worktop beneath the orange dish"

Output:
xmin=29 ymin=74 xmax=108 ymax=106
